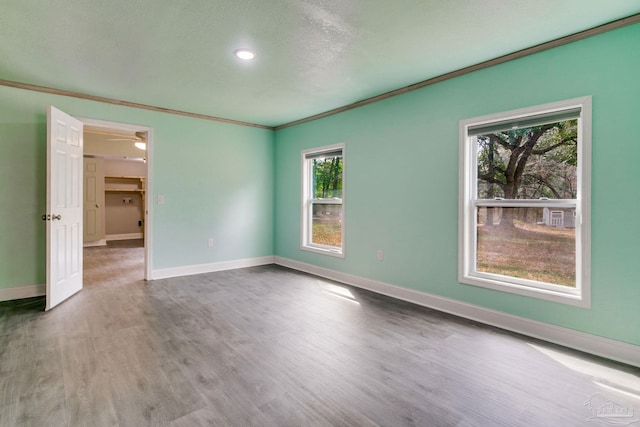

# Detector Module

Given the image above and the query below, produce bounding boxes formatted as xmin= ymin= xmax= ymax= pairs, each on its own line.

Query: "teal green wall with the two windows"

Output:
xmin=275 ymin=24 xmax=640 ymax=344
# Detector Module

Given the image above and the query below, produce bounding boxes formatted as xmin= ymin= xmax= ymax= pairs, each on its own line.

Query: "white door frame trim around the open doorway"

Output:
xmin=74 ymin=116 xmax=153 ymax=280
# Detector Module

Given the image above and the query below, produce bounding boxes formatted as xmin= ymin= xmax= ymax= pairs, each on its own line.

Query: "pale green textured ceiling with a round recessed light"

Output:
xmin=0 ymin=0 xmax=640 ymax=126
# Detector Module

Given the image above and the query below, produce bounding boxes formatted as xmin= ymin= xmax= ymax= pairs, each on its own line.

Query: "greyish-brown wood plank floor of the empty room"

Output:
xmin=0 ymin=243 xmax=640 ymax=427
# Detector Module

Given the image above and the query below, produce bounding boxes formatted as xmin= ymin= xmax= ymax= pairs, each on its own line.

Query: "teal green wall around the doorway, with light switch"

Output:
xmin=0 ymin=86 xmax=274 ymax=288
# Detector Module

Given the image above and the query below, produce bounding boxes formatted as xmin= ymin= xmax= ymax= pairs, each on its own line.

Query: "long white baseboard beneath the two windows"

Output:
xmin=275 ymin=257 xmax=640 ymax=367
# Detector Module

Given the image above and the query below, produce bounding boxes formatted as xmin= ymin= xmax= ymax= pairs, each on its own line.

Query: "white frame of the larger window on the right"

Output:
xmin=458 ymin=96 xmax=592 ymax=308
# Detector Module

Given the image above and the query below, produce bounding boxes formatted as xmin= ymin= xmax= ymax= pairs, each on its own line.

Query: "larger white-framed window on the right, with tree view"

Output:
xmin=458 ymin=97 xmax=591 ymax=307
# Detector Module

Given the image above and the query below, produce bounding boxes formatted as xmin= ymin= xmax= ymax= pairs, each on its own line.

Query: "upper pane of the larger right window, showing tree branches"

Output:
xmin=476 ymin=119 xmax=578 ymax=199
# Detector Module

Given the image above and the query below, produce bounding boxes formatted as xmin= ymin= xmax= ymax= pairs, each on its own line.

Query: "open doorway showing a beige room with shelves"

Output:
xmin=79 ymin=118 xmax=153 ymax=284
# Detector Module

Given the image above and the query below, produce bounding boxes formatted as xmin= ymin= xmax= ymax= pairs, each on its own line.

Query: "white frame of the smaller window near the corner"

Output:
xmin=300 ymin=143 xmax=346 ymax=258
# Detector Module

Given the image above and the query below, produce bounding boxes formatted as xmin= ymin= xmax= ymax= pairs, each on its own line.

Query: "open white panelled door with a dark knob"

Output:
xmin=42 ymin=106 xmax=83 ymax=310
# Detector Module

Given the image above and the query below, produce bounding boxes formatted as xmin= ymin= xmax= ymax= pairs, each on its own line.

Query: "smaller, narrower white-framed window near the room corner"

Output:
xmin=302 ymin=144 xmax=344 ymax=257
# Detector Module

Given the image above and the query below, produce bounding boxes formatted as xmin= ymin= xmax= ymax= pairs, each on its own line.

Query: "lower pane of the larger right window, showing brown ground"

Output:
xmin=476 ymin=207 xmax=576 ymax=287
